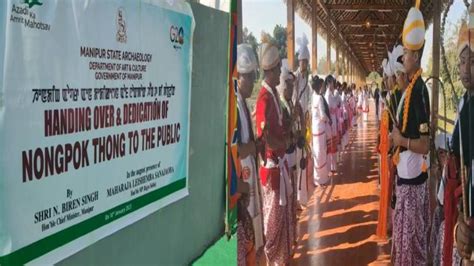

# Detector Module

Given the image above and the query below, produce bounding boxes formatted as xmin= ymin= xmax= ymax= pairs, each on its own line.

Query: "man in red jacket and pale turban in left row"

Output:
xmin=255 ymin=39 xmax=291 ymax=265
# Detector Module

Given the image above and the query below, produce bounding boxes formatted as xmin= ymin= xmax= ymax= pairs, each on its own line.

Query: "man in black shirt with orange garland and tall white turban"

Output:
xmin=392 ymin=1 xmax=430 ymax=265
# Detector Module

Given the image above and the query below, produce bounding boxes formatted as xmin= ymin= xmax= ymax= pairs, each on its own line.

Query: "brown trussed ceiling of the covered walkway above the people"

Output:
xmin=284 ymin=0 xmax=447 ymax=74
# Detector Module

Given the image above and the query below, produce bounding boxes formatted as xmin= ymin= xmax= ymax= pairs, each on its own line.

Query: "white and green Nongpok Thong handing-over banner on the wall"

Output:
xmin=0 ymin=0 xmax=194 ymax=265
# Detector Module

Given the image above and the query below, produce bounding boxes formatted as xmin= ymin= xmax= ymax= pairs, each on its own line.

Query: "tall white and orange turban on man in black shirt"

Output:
xmin=402 ymin=0 xmax=425 ymax=51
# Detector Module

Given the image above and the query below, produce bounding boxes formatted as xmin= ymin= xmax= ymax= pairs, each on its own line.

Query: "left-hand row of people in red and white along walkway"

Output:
xmin=235 ymin=33 xmax=368 ymax=265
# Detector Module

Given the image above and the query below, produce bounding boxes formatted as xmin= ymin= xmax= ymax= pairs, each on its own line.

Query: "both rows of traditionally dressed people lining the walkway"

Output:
xmin=235 ymin=1 xmax=474 ymax=265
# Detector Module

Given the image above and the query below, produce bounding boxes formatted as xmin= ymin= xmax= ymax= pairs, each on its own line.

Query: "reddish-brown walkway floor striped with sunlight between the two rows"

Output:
xmin=292 ymin=102 xmax=390 ymax=265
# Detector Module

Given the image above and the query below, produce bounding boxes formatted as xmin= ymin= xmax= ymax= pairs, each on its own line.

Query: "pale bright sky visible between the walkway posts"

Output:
xmin=242 ymin=0 xmax=471 ymax=73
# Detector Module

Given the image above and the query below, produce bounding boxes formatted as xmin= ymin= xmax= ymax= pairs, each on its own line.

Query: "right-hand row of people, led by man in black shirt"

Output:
xmin=377 ymin=3 xmax=474 ymax=265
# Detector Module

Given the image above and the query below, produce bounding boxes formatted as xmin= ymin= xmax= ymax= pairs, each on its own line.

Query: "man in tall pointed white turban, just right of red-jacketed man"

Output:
xmin=293 ymin=34 xmax=311 ymax=205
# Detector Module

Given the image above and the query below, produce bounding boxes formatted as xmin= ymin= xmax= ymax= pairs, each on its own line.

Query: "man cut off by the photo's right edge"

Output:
xmin=450 ymin=4 xmax=474 ymax=265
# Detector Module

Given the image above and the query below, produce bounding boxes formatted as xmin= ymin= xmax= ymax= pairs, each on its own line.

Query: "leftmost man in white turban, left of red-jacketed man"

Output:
xmin=234 ymin=44 xmax=263 ymax=265
